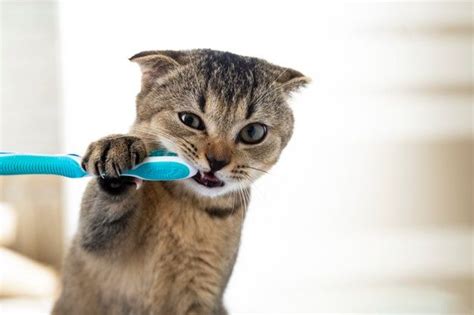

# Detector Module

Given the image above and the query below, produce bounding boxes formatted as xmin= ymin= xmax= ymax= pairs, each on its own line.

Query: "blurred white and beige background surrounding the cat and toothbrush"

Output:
xmin=0 ymin=0 xmax=474 ymax=315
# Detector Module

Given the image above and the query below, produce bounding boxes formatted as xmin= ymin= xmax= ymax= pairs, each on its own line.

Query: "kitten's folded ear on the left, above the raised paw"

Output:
xmin=129 ymin=50 xmax=189 ymax=86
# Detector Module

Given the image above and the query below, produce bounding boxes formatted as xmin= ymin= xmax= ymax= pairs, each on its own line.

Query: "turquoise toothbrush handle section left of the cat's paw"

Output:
xmin=0 ymin=153 xmax=88 ymax=178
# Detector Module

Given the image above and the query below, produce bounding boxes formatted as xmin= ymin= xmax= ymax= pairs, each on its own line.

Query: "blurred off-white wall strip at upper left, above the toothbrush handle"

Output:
xmin=0 ymin=2 xmax=62 ymax=153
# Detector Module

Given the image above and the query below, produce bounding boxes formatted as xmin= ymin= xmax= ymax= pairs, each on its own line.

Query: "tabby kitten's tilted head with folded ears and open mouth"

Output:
xmin=130 ymin=50 xmax=309 ymax=196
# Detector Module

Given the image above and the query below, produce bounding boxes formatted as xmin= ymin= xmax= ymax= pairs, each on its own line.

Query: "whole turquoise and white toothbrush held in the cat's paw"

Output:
xmin=0 ymin=150 xmax=197 ymax=181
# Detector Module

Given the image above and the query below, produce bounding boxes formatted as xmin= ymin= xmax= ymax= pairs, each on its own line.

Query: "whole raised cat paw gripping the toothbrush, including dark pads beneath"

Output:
xmin=82 ymin=135 xmax=147 ymax=195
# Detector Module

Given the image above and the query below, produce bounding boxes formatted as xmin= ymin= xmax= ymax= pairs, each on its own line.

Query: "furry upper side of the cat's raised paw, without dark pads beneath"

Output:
xmin=82 ymin=135 xmax=147 ymax=178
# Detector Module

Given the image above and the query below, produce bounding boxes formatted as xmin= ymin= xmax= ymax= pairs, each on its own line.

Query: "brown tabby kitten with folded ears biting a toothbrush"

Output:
xmin=53 ymin=49 xmax=309 ymax=315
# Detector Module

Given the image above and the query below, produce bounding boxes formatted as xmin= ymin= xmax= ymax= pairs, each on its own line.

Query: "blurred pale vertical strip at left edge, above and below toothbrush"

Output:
xmin=0 ymin=1 xmax=63 ymax=266
